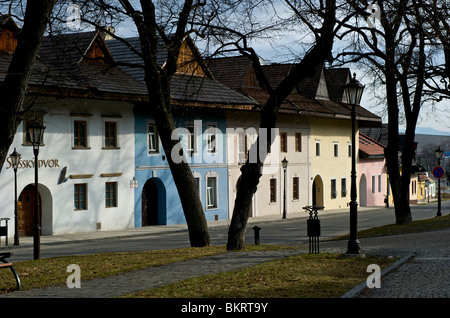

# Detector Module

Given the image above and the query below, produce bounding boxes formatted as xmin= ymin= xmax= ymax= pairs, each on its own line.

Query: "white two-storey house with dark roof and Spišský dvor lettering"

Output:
xmin=0 ymin=28 xmax=146 ymax=241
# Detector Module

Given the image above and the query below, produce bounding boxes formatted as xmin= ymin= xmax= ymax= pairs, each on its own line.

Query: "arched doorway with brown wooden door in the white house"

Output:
xmin=17 ymin=184 xmax=42 ymax=236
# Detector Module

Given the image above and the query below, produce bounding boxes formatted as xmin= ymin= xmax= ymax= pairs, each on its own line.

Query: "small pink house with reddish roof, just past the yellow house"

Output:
xmin=357 ymin=133 xmax=387 ymax=206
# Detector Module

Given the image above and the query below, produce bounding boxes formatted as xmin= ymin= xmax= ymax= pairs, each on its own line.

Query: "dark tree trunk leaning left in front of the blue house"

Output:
xmin=133 ymin=1 xmax=210 ymax=247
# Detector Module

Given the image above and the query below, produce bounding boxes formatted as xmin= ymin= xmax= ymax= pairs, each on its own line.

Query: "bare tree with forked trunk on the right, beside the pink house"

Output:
xmin=337 ymin=0 xmax=448 ymax=224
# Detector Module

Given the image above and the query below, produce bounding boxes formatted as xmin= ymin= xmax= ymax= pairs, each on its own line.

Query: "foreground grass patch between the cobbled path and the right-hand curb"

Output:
xmin=123 ymin=254 xmax=396 ymax=298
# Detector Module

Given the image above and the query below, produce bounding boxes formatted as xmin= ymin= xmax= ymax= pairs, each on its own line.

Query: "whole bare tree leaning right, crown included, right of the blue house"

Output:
xmin=191 ymin=0 xmax=337 ymax=250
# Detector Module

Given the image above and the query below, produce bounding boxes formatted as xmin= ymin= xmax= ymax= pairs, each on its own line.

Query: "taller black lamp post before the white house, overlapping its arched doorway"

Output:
xmin=28 ymin=119 xmax=45 ymax=259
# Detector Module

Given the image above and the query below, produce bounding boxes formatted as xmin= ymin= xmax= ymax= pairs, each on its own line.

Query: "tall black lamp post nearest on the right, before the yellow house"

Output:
xmin=344 ymin=74 xmax=364 ymax=254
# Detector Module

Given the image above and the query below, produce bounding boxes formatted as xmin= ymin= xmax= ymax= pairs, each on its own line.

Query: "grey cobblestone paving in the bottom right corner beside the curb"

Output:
xmin=321 ymin=230 xmax=450 ymax=298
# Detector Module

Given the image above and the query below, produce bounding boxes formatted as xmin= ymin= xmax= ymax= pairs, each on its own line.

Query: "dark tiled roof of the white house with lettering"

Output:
xmin=0 ymin=32 xmax=147 ymax=100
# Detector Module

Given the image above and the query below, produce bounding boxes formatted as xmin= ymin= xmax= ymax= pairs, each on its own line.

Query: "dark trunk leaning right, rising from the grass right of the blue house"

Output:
xmin=227 ymin=1 xmax=336 ymax=250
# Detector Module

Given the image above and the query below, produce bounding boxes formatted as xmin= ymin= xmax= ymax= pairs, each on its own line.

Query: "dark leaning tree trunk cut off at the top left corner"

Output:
xmin=0 ymin=0 xmax=56 ymax=169
